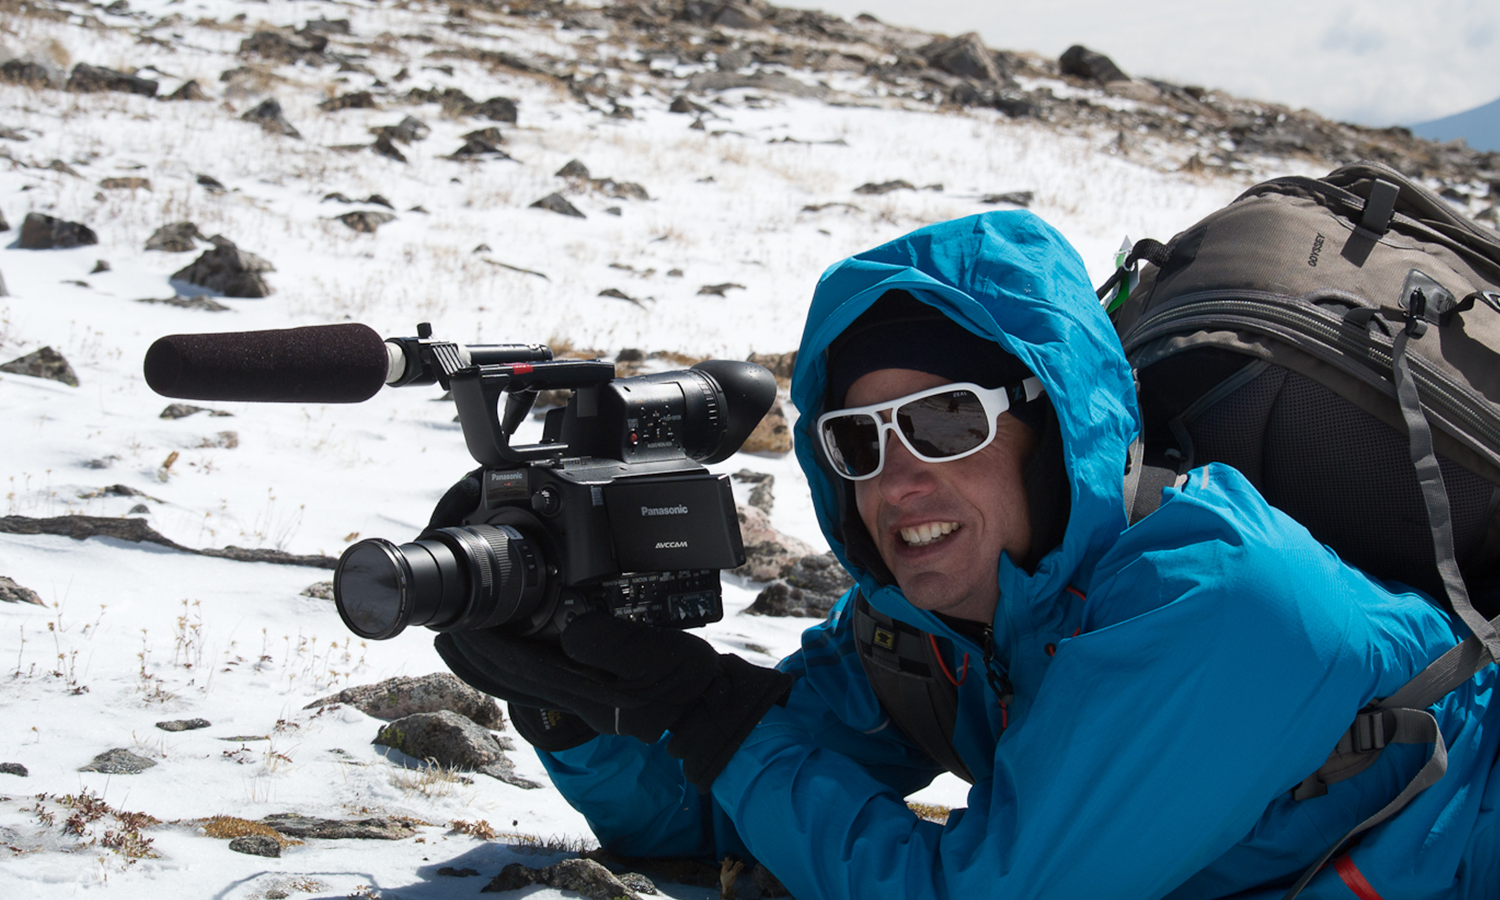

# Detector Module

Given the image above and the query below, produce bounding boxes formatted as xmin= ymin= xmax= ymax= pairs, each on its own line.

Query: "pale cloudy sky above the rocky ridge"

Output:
xmin=780 ymin=0 xmax=1500 ymax=126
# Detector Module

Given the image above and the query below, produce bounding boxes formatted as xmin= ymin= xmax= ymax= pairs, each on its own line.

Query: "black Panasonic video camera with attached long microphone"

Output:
xmin=146 ymin=323 xmax=776 ymax=641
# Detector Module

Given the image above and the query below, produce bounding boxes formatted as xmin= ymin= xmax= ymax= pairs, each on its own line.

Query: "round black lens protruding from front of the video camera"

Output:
xmin=333 ymin=525 xmax=546 ymax=641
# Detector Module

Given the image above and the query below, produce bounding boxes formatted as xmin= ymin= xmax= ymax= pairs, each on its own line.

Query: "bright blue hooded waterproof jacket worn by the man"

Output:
xmin=543 ymin=213 xmax=1500 ymax=900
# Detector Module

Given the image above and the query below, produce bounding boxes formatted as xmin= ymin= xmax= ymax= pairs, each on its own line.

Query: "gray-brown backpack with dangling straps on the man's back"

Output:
xmin=1101 ymin=164 xmax=1500 ymax=897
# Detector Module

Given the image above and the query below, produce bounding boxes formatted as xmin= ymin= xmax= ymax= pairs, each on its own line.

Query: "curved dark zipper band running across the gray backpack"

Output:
xmin=1125 ymin=290 xmax=1500 ymax=447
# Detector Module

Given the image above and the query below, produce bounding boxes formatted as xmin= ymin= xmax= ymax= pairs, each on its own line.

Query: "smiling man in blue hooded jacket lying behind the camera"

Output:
xmin=438 ymin=213 xmax=1500 ymax=900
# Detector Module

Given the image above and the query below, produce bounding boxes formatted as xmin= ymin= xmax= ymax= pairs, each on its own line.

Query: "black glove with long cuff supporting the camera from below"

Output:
xmin=437 ymin=612 xmax=794 ymax=792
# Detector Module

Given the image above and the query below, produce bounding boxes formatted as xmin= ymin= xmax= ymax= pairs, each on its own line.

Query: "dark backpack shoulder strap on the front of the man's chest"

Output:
xmin=852 ymin=593 xmax=974 ymax=785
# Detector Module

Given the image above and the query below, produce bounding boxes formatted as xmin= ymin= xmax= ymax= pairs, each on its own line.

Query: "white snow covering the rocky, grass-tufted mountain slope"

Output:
xmin=0 ymin=0 xmax=1284 ymax=899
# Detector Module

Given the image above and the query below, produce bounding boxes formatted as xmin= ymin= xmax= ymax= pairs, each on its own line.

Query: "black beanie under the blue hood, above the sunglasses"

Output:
xmin=824 ymin=291 xmax=1043 ymax=428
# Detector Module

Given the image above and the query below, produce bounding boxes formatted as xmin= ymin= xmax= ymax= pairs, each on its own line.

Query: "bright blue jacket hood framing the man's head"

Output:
xmin=792 ymin=212 xmax=1140 ymax=636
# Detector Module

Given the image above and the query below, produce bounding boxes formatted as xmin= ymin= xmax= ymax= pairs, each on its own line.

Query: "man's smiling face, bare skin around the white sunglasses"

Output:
xmin=845 ymin=369 xmax=1037 ymax=624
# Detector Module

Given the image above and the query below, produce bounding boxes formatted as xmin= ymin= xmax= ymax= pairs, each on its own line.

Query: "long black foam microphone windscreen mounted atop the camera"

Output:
xmin=146 ymin=324 xmax=390 ymax=404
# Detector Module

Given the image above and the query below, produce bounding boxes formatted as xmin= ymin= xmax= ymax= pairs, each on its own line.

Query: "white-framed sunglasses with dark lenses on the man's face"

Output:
xmin=818 ymin=375 xmax=1043 ymax=482
